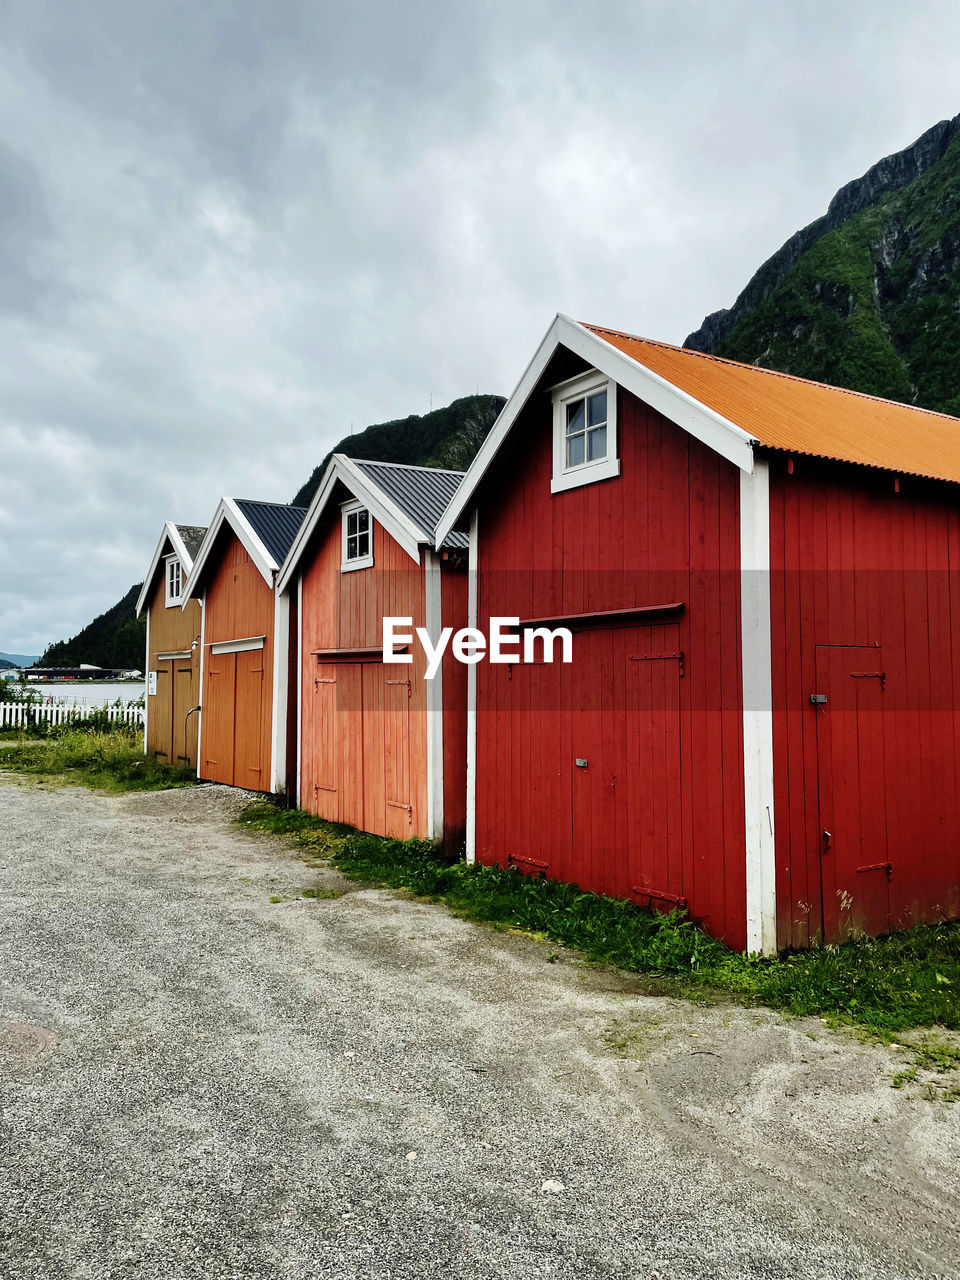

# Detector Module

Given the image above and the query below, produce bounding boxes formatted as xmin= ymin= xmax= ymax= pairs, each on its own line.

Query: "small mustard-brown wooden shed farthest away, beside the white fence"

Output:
xmin=137 ymin=521 xmax=206 ymax=767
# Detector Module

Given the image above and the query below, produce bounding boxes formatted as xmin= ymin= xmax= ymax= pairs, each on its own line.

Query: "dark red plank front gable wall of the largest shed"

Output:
xmin=476 ymin=389 xmax=746 ymax=947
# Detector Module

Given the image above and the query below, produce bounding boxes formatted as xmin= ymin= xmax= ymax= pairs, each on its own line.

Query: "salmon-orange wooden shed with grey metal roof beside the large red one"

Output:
xmin=279 ymin=454 xmax=467 ymax=849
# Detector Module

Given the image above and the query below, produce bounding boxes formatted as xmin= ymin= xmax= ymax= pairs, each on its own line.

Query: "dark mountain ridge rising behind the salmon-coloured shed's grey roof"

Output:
xmin=292 ymin=396 xmax=506 ymax=507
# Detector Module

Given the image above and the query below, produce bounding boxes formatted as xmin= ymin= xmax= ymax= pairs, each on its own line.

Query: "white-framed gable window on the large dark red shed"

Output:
xmin=550 ymin=370 xmax=620 ymax=493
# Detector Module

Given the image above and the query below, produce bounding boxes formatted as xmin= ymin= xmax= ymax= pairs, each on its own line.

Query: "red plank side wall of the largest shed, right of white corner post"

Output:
xmin=771 ymin=460 xmax=960 ymax=946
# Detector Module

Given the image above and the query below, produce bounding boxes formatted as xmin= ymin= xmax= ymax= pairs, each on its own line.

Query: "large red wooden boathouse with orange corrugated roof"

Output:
xmin=438 ymin=309 xmax=960 ymax=952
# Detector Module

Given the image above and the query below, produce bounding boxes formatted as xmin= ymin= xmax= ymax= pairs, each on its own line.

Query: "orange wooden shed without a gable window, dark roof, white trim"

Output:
xmin=184 ymin=498 xmax=305 ymax=791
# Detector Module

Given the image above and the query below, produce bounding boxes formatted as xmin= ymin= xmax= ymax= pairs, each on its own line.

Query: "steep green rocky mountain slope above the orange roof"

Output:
xmin=685 ymin=116 xmax=960 ymax=415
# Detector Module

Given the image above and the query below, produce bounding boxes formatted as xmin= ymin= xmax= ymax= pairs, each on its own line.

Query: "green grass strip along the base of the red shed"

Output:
xmin=239 ymin=801 xmax=960 ymax=1049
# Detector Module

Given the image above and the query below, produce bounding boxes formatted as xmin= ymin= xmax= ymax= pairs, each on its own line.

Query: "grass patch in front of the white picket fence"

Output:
xmin=0 ymin=728 xmax=197 ymax=791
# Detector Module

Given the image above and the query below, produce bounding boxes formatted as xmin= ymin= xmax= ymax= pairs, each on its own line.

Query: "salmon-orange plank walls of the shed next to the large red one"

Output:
xmin=300 ymin=511 xmax=466 ymax=840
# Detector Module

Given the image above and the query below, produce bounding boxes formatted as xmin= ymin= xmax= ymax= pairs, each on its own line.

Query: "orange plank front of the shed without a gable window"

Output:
xmin=200 ymin=529 xmax=274 ymax=791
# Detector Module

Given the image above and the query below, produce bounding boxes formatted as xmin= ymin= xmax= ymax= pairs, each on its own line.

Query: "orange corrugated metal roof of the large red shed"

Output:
xmin=584 ymin=324 xmax=960 ymax=483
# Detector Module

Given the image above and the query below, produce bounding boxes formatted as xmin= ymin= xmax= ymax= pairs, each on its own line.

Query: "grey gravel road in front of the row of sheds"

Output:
xmin=0 ymin=777 xmax=960 ymax=1280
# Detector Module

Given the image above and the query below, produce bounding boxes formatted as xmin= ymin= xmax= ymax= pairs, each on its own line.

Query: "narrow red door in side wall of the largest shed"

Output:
xmin=814 ymin=645 xmax=892 ymax=942
